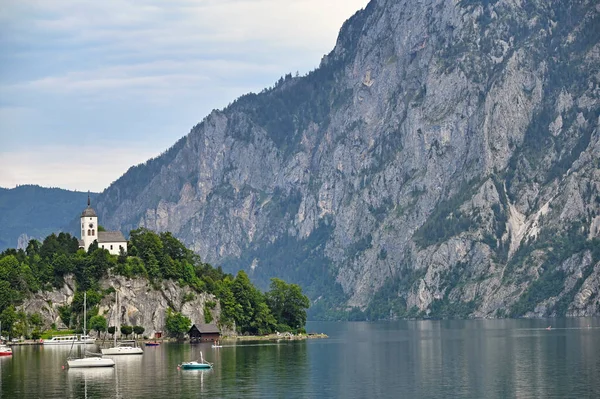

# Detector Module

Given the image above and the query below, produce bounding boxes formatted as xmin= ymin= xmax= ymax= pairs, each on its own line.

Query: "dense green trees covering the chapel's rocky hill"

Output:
xmin=0 ymin=229 xmax=309 ymax=336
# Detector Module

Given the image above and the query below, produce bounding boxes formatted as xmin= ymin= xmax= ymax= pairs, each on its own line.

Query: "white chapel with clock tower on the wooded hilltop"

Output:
xmin=79 ymin=196 xmax=127 ymax=255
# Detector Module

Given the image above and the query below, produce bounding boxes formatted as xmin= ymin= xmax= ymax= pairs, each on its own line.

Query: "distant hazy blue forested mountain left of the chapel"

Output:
xmin=0 ymin=185 xmax=98 ymax=251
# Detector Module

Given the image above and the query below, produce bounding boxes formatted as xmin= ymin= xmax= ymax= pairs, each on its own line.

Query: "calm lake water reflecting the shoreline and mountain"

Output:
xmin=0 ymin=318 xmax=600 ymax=398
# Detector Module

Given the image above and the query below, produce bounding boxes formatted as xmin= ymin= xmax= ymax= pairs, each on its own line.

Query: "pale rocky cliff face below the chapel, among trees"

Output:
xmin=20 ymin=276 xmax=230 ymax=338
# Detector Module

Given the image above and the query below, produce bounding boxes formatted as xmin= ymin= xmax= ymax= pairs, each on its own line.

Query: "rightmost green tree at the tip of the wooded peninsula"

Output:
xmin=266 ymin=278 xmax=310 ymax=331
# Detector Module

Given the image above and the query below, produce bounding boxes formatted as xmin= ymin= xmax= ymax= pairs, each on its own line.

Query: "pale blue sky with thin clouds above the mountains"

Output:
xmin=0 ymin=0 xmax=368 ymax=192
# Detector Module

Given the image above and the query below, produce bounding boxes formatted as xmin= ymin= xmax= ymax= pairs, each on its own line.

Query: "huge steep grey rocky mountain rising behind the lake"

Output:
xmin=97 ymin=0 xmax=600 ymax=319
